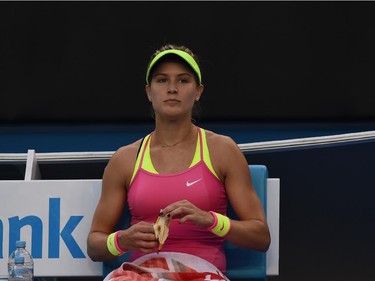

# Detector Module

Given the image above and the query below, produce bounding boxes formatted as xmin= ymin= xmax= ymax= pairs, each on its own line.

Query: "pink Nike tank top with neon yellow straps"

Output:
xmin=128 ymin=128 xmax=227 ymax=272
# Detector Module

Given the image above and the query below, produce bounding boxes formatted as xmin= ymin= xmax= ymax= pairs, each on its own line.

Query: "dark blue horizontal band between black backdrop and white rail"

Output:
xmin=0 ymin=122 xmax=375 ymax=153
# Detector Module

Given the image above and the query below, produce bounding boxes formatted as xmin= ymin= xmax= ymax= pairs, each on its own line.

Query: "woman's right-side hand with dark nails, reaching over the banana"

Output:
xmin=161 ymin=200 xmax=214 ymax=227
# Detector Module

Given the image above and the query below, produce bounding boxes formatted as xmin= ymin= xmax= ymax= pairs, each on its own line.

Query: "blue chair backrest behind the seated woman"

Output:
xmin=103 ymin=165 xmax=268 ymax=280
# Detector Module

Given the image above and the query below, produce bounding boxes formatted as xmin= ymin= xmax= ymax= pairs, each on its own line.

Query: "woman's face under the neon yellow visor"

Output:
xmin=146 ymin=61 xmax=203 ymax=118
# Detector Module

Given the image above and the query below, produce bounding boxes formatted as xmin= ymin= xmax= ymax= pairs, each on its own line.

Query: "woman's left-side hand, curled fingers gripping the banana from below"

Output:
xmin=117 ymin=222 xmax=159 ymax=254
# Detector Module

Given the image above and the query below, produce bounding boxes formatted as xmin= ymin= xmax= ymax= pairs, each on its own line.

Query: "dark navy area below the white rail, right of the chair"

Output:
xmin=247 ymin=141 xmax=375 ymax=281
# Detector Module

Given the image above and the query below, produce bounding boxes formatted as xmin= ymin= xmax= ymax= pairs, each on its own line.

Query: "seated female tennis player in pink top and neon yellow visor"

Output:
xmin=88 ymin=45 xmax=270 ymax=274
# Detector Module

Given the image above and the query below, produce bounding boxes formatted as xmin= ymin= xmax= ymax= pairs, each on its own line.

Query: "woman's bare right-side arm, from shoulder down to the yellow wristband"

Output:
xmin=208 ymin=133 xmax=271 ymax=251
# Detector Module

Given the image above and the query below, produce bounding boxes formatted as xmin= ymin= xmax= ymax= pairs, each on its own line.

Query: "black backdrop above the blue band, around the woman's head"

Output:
xmin=0 ymin=1 xmax=375 ymax=124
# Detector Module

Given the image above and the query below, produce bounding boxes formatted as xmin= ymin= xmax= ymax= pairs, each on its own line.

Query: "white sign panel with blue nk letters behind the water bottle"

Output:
xmin=0 ymin=180 xmax=102 ymax=278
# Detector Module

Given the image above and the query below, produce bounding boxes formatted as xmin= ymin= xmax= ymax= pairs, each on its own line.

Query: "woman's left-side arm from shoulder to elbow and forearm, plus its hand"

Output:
xmin=87 ymin=141 xmax=157 ymax=261
